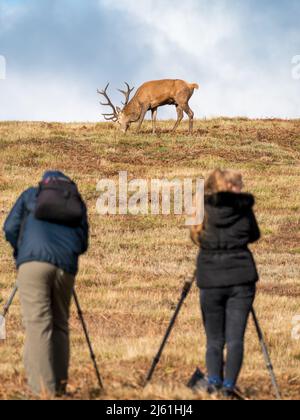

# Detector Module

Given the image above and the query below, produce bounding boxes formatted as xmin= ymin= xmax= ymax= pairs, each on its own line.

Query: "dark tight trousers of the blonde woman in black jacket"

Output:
xmin=201 ymin=284 xmax=256 ymax=387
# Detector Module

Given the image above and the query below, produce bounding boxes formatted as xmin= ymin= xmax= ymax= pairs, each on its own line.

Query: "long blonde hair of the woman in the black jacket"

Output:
xmin=190 ymin=169 xmax=243 ymax=246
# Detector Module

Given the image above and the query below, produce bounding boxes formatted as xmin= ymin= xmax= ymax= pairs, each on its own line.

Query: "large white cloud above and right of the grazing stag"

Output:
xmin=99 ymin=0 xmax=300 ymax=118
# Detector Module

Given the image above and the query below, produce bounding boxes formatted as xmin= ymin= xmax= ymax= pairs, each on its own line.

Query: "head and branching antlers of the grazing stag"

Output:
xmin=97 ymin=82 xmax=135 ymax=133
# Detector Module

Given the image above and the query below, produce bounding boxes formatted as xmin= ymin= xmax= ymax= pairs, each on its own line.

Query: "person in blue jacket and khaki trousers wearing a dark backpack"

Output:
xmin=4 ymin=172 xmax=89 ymax=395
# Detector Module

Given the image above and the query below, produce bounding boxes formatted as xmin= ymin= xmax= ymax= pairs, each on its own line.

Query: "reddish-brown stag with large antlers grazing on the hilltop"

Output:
xmin=98 ymin=80 xmax=199 ymax=134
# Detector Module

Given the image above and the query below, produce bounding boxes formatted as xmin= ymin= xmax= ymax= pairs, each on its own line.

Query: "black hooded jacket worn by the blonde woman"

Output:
xmin=197 ymin=192 xmax=260 ymax=289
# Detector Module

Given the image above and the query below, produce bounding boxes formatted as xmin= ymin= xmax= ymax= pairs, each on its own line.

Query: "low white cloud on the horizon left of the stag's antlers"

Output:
xmin=0 ymin=74 xmax=100 ymax=122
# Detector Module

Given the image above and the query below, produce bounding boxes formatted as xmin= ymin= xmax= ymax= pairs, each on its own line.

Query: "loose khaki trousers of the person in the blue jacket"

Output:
xmin=18 ymin=262 xmax=75 ymax=395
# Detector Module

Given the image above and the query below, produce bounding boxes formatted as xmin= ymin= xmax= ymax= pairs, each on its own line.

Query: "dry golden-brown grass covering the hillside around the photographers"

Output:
xmin=0 ymin=119 xmax=300 ymax=399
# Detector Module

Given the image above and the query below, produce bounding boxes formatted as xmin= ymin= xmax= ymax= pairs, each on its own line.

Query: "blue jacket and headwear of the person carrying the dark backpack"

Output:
xmin=4 ymin=171 xmax=89 ymax=275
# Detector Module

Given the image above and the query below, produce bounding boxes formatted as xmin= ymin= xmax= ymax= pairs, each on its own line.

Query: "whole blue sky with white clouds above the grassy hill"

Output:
xmin=0 ymin=0 xmax=300 ymax=121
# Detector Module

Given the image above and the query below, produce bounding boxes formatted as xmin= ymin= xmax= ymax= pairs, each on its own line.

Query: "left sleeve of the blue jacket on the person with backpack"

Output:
xmin=3 ymin=193 xmax=25 ymax=254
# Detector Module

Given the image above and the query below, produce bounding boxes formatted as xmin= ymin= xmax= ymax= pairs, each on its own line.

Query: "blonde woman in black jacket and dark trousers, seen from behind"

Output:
xmin=191 ymin=170 xmax=260 ymax=396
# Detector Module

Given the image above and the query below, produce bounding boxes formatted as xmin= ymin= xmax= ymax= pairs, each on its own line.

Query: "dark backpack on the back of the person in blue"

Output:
xmin=34 ymin=178 xmax=85 ymax=227
